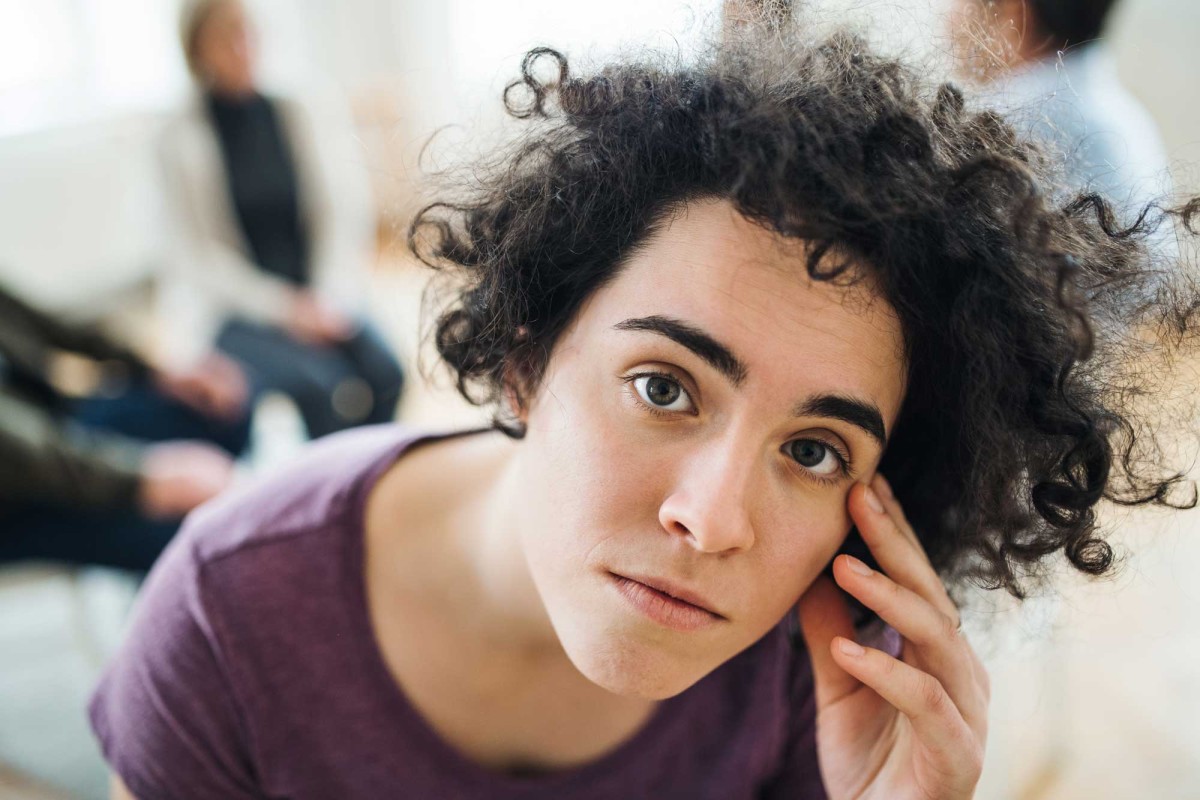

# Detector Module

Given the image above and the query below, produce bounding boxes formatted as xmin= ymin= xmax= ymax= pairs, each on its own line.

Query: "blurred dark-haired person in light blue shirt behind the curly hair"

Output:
xmin=950 ymin=0 xmax=1174 ymax=215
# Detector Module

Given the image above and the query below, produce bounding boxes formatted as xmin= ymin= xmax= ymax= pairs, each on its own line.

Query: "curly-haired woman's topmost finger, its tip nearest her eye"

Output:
xmin=850 ymin=485 xmax=959 ymax=624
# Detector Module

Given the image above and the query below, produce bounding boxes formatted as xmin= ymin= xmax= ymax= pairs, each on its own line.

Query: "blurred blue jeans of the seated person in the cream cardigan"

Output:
xmin=217 ymin=319 xmax=404 ymax=439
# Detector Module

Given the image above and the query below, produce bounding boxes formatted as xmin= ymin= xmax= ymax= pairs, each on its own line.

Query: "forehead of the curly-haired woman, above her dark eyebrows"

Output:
xmin=582 ymin=200 xmax=905 ymax=417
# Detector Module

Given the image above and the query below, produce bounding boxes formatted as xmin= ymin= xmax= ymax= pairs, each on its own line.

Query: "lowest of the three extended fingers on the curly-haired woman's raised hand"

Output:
xmin=830 ymin=637 xmax=984 ymax=790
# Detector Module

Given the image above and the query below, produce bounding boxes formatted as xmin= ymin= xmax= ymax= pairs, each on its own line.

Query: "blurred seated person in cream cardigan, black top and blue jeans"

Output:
xmin=162 ymin=0 xmax=403 ymax=437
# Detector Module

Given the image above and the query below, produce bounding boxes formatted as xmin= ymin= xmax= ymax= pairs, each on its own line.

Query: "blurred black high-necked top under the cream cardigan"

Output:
xmin=208 ymin=94 xmax=310 ymax=285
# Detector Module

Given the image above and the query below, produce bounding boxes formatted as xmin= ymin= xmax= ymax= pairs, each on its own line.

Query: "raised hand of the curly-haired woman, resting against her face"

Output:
xmin=799 ymin=476 xmax=990 ymax=800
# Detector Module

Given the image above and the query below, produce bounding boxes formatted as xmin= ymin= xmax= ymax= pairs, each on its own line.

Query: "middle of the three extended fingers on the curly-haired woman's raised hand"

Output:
xmin=834 ymin=555 xmax=988 ymax=732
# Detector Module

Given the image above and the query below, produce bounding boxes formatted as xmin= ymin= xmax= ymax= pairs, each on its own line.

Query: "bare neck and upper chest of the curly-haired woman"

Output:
xmin=366 ymin=433 xmax=658 ymax=770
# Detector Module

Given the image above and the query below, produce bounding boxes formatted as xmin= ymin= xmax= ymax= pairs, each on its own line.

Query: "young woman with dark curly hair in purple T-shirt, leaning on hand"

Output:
xmin=91 ymin=21 xmax=1190 ymax=800
